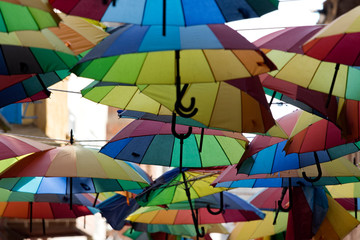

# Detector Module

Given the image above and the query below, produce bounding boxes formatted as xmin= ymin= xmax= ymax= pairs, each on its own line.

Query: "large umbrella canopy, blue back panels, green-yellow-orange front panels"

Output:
xmin=72 ymin=24 xmax=275 ymax=85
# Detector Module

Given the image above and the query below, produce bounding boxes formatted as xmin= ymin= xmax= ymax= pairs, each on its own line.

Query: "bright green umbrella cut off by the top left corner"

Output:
xmin=0 ymin=0 xmax=60 ymax=32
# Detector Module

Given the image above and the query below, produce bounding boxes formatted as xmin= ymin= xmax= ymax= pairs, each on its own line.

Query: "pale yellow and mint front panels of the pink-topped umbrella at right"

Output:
xmin=262 ymin=25 xmax=360 ymax=103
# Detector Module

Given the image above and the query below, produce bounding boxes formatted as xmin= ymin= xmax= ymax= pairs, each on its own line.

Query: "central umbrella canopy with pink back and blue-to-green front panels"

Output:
xmin=100 ymin=120 xmax=248 ymax=167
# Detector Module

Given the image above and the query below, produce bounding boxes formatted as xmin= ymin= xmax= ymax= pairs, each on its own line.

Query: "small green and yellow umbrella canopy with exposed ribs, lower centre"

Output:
xmin=136 ymin=168 xmax=225 ymax=206
